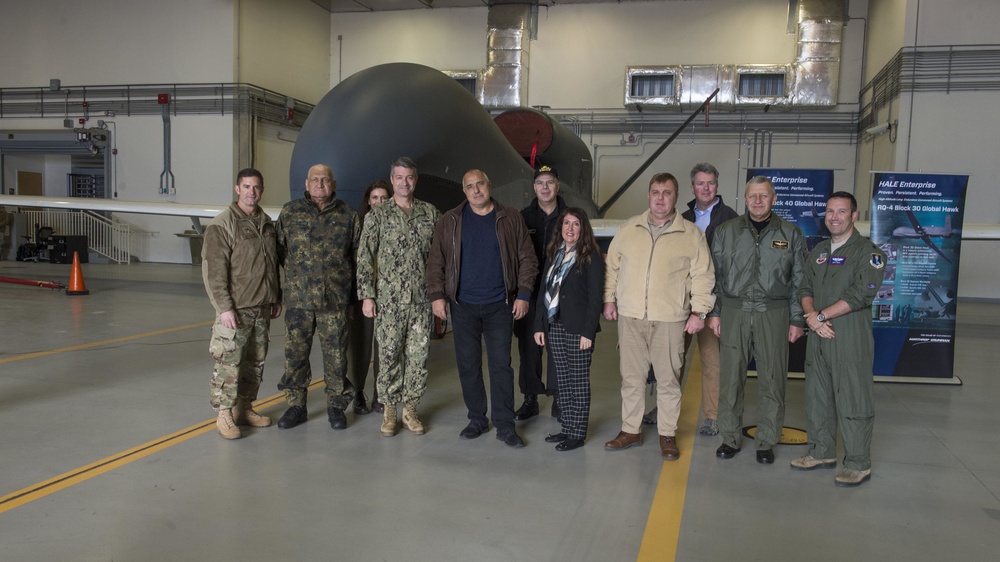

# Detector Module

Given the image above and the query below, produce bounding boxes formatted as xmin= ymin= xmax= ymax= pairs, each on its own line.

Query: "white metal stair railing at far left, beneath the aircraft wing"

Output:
xmin=21 ymin=210 xmax=150 ymax=263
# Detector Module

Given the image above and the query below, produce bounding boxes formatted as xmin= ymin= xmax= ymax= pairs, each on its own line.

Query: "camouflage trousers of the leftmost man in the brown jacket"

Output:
xmin=208 ymin=304 xmax=271 ymax=410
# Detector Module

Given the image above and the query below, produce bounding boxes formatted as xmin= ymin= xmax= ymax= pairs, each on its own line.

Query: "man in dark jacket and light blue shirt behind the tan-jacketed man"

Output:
xmin=642 ymin=162 xmax=739 ymax=435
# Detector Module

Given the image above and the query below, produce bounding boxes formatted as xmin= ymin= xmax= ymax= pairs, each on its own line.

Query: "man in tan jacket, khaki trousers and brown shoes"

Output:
xmin=604 ymin=173 xmax=715 ymax=460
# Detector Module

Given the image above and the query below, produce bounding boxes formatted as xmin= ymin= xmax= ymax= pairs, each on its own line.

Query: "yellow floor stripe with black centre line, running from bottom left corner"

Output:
xmin=0 ymin=378 xmax=323 ymax=513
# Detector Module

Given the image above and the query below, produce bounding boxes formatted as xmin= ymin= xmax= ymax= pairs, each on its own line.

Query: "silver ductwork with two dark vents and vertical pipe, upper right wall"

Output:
xmin=625 ymin=0 xmax=845 ymax=111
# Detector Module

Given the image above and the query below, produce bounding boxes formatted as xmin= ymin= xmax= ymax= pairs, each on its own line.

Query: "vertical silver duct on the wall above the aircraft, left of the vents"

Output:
xmin=477 ymin=3 xmax=534 ymax=108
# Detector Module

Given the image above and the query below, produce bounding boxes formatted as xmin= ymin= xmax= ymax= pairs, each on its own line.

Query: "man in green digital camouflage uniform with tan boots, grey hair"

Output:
xmin=358 ymin=158 xmax=441 ymax=437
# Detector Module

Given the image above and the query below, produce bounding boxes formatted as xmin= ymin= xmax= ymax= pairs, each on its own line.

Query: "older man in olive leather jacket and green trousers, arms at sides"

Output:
xmin=708 ymin=176 xmax=806 ymax=464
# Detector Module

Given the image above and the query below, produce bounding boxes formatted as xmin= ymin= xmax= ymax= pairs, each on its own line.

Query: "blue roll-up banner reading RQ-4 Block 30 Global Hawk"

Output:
xmin=870 ymin=172 xmax=969 ymax=384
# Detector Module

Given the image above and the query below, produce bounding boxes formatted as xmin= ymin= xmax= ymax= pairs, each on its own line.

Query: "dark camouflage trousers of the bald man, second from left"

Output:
xmin=278 ymin=307 xmax=354 ymax=410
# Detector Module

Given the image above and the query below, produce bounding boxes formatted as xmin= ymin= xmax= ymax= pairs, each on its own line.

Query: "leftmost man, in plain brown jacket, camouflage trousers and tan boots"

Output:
xmin=201 ymin=168 xmax=281 ymax=439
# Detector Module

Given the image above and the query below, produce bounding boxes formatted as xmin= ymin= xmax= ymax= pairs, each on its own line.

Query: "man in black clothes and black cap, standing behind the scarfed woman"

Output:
xmin=514 ymin=166 xmax=566 ymax=421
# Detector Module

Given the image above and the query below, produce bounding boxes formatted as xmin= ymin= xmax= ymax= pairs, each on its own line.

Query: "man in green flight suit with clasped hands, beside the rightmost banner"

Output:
xmin=791 ymin=191 xmax=886 ymax=486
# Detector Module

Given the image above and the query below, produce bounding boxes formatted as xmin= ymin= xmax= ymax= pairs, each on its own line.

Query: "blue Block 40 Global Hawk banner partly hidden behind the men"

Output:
xmin=747 ymin=168 xmax=833 ymax=378
